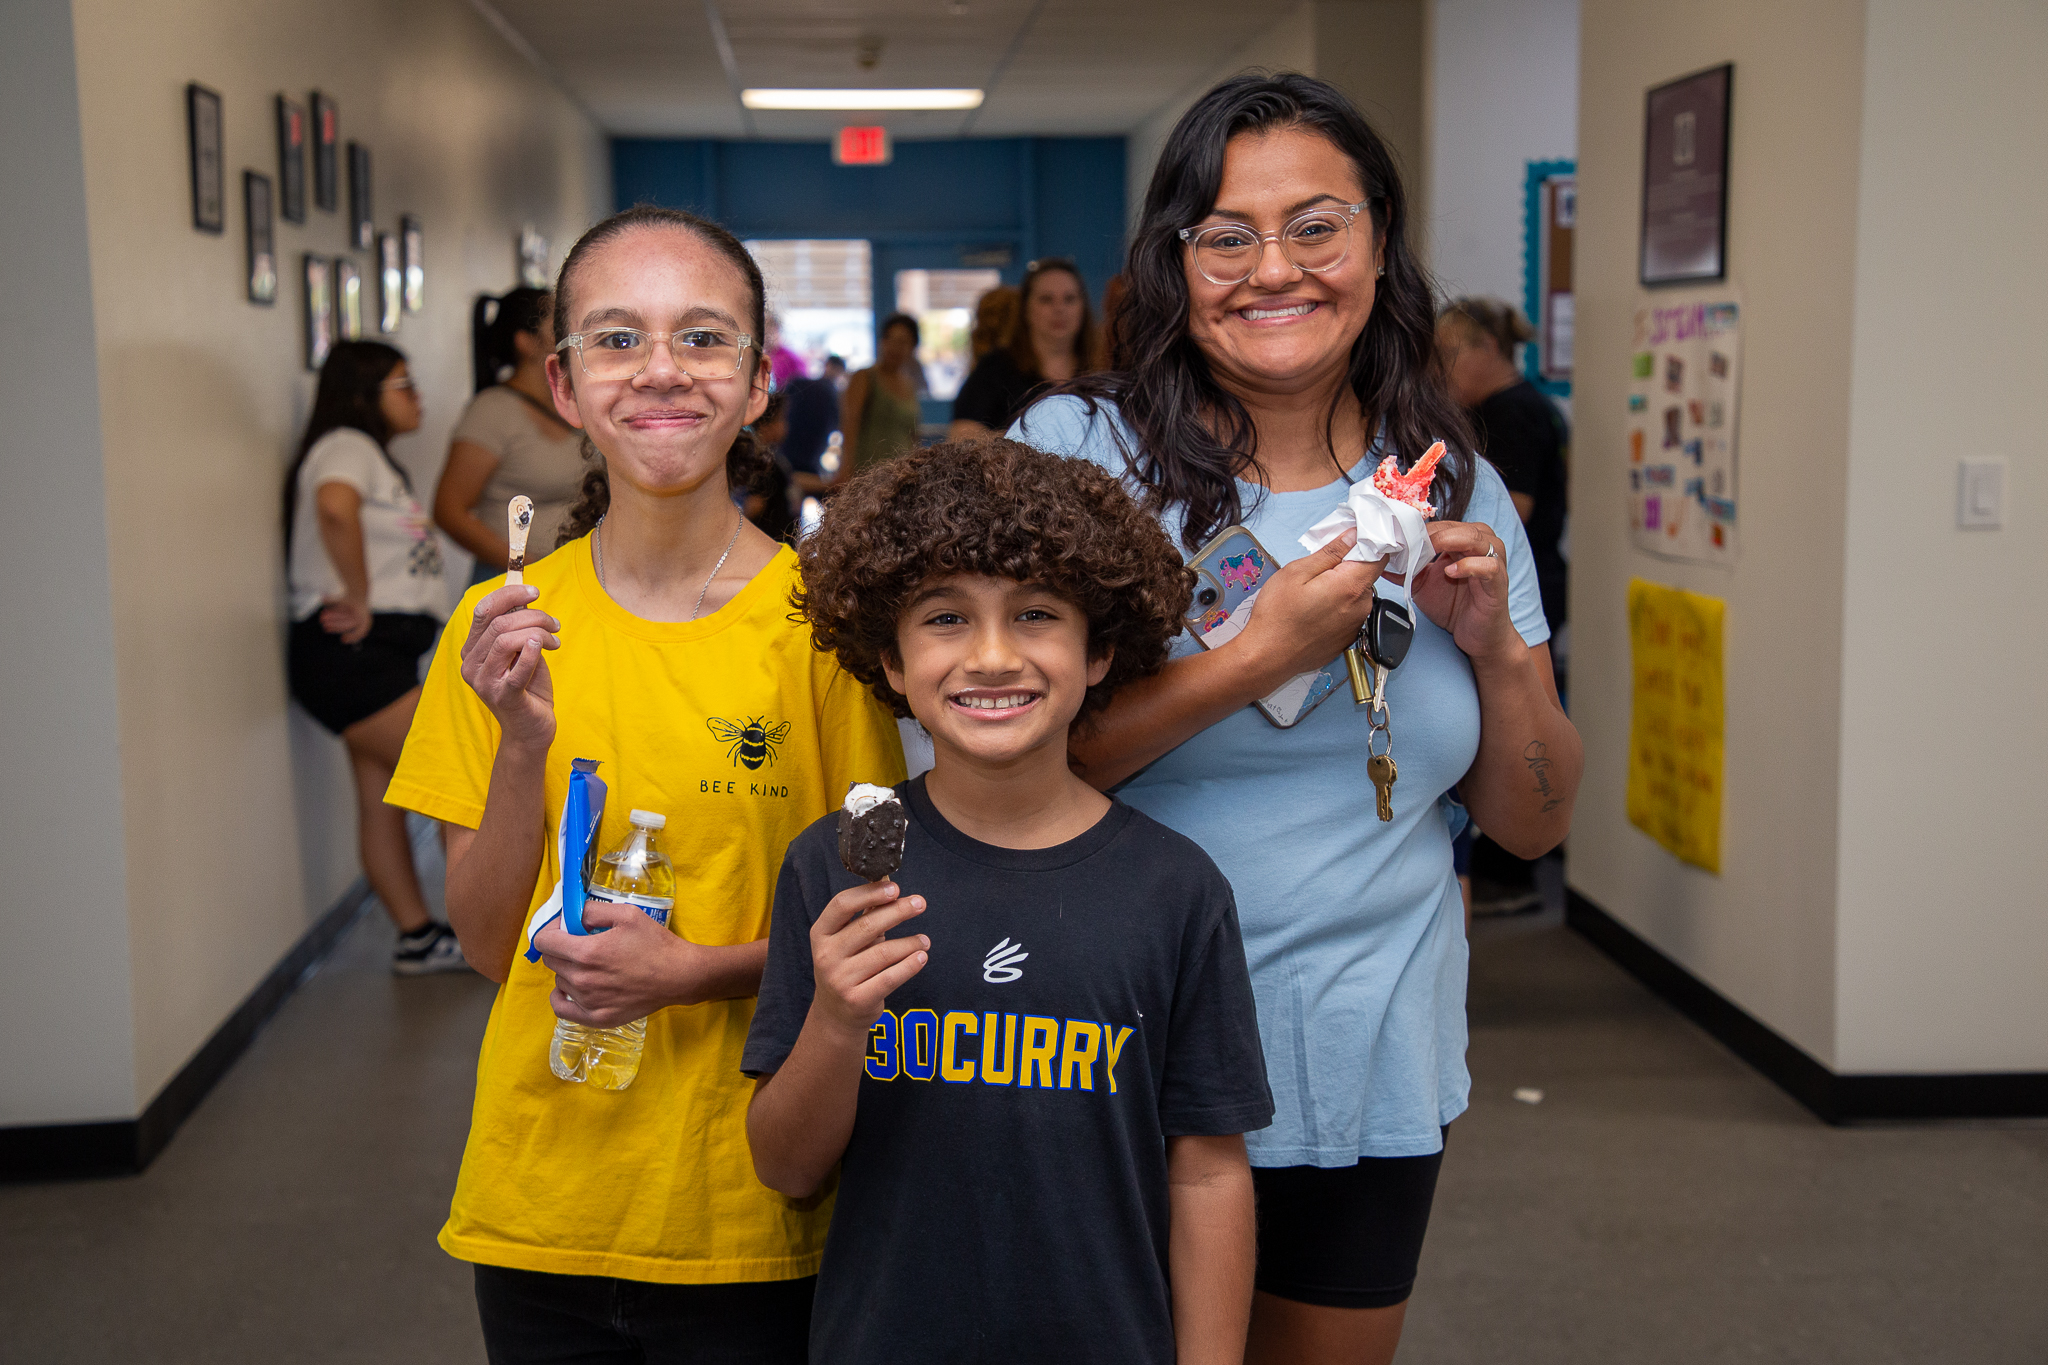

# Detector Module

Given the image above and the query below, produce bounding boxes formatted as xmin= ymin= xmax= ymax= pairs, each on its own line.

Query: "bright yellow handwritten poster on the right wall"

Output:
xmin=1628 ymin=579 xmax=1726 ymax=876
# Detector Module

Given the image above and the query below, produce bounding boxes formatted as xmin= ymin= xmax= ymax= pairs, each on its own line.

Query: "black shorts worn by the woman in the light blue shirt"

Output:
xmin=1251 ymin=1130 xmax=1448 ymax=1308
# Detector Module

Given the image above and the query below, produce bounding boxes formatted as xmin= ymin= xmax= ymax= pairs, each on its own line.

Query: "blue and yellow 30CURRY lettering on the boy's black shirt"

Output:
xmin=866 ymin=1009 xmax=1133 ymax=1095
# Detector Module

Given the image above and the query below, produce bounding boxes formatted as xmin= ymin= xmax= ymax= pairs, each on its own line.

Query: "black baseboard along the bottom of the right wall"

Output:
xmin=1565 ymin=888 xmax=2048 ymax=1124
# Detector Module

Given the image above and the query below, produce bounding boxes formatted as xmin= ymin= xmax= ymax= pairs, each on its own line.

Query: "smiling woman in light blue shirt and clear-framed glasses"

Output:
xmin=1012 ymin=76 xmax=1581 ymax=1365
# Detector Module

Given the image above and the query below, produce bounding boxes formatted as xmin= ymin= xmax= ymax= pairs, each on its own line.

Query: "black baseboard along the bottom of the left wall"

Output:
xmin=0 ymin=878 xmax=371 ymax=1181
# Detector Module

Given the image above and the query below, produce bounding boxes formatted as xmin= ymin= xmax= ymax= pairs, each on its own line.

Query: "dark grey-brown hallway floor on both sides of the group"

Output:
xmin=0 ymin=888 xmax=2048 ymax=1365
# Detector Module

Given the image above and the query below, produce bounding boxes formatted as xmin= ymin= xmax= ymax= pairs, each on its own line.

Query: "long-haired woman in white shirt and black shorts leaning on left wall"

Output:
xmin=285 ymin=342 xmax=467 ymax=976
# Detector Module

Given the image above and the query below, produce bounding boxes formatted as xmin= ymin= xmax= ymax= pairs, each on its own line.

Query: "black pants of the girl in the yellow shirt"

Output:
xmin=475 ymin=1265 xmax=817 ymax=1365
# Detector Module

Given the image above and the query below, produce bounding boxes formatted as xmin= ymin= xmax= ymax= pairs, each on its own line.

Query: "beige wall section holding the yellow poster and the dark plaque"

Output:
xmin=1571 ymin=0 xmax=1864 ymax=1066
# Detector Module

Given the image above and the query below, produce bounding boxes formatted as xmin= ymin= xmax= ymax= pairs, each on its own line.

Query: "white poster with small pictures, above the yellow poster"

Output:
xmin=1628 ymin=295 xmax=1743 ymax=565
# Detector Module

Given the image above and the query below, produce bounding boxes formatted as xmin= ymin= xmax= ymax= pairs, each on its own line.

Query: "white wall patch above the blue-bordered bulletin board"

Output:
xmin=1417 ymin=0 xmax=1579 ymax=307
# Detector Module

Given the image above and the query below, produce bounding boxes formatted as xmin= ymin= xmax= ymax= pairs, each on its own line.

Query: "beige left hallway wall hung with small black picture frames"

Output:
xmin=58 ymin=0 xmax=608 ymax=1105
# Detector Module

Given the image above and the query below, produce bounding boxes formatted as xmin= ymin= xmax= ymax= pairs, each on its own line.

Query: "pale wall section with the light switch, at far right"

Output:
xmin=1835 ymin=0 xmax=2048 ymax=1072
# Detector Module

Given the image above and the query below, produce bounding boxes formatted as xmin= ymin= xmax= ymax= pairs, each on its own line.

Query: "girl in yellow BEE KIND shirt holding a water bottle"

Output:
xmin=389 ymin=207 xmax=903 ymax=1365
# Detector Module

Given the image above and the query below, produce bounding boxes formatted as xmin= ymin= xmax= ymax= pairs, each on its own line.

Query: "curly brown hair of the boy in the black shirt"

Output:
xmin=793 ymin=438 xmax=1194 ymax=716
